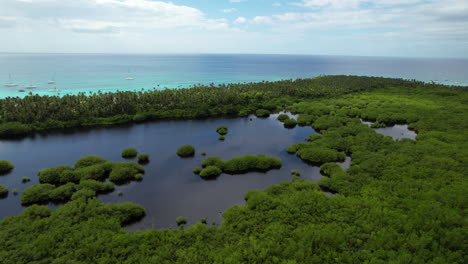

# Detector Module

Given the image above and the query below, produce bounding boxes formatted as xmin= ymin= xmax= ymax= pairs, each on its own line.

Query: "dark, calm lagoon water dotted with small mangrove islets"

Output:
xmin=0 ymin=115 xmax=326 ymax=230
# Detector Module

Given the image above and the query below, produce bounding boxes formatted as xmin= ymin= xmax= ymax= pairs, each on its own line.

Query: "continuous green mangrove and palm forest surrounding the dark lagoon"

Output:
xmin=0 ymin=76 xmax=468 ymax=264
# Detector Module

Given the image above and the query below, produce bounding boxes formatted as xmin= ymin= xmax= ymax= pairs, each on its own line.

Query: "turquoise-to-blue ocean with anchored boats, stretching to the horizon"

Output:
xmin=0 ymin=53 xmax=468 ymax=98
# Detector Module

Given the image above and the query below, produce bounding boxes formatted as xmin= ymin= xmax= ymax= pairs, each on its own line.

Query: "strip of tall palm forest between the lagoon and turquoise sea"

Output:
xmin=0 ymin=76 xmax=466 ymax=137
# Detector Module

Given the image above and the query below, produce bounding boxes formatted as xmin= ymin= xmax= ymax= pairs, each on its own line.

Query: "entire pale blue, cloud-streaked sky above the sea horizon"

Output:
xmin=0 ymin=0 xmax=468 ymax=58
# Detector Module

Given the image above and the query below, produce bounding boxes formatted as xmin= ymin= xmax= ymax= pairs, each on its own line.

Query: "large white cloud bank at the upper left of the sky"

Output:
xmin=0 ymin=0 xmax=234 ymax=33
